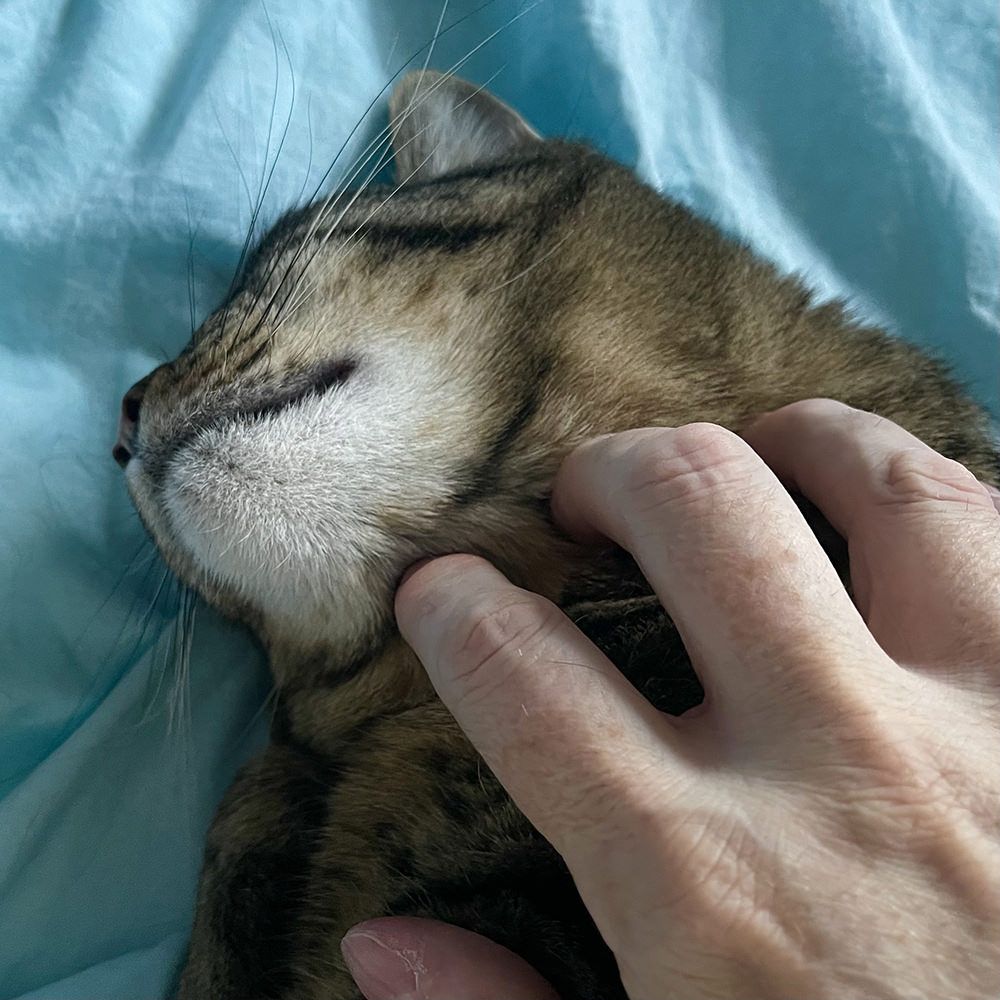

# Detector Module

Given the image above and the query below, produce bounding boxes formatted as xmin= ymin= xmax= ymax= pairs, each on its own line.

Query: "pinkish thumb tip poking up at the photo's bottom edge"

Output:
xmin=340 ymin=917 xmax=559 ymax=1000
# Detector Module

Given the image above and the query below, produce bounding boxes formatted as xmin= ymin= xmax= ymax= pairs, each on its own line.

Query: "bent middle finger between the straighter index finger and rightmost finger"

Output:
xmin=553 ymin=424 xmax=876 ymax=713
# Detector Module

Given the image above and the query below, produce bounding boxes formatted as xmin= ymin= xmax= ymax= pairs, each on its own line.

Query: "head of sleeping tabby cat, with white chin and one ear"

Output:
xmin=115 ymin=73 xmax=684 ymax=672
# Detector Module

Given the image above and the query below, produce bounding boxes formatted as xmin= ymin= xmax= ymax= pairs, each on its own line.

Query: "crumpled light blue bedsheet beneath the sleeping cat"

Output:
xmin=0 ymin=0 xmax=1000 ymax=1000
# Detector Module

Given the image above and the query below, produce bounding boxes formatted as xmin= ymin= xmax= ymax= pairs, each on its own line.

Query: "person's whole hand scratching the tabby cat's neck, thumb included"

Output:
xmin=345 ymin=400 xmax=1000 ymax=1000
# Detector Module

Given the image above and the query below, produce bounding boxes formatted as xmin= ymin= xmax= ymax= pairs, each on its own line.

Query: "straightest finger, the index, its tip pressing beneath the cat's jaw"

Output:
xmin=396 ymin=556 xmax=679 ymax=861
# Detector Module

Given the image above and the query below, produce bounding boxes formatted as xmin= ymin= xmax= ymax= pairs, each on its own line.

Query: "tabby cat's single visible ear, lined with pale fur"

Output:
xmin=389 ymin=70 xmax=541 ymax=183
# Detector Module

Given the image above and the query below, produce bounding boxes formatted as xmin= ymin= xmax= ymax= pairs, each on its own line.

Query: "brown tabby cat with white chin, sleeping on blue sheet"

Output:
xmin=114 ymin=72 xmax=1000 ymax=1000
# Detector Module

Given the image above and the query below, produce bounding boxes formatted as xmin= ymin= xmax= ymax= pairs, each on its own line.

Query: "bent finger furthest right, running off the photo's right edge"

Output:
xmin=746 ymin=399 xmax=1000 ymax=671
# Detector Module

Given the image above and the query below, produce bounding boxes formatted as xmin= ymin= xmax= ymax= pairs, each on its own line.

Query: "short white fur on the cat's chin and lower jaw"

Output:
xmin=163 ymin=352 xmax=461 ymax=626
